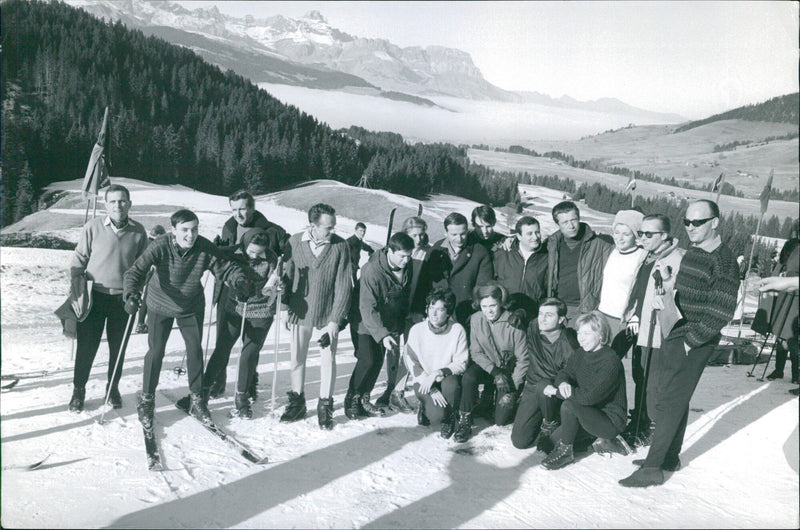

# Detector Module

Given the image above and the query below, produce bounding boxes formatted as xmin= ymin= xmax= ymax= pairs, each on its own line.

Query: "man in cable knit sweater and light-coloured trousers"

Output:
xmin=281 ymin=203 xmax=353 ymax=429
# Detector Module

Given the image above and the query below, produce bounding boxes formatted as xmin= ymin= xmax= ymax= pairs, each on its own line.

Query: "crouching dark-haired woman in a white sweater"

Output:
xmin=406 ymin=289 xmax=469 ymax=438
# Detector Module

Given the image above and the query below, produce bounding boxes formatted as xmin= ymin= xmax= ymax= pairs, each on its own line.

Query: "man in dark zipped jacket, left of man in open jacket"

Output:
xmin=493 ymin=215 xmax=548 ymax=326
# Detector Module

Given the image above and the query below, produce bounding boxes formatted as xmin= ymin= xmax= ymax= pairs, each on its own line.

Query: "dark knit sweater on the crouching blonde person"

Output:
xmin=555 ymin=346 xmax=628 ymax=432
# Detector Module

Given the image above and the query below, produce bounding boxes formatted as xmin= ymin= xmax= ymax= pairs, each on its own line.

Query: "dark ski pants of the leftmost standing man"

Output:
xmin=72 ymin=291 xmax=128 ymax=388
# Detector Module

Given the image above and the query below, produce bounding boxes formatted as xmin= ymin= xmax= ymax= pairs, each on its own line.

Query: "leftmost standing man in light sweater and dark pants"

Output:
xmin=69 ymin=184 xmax=147 ymax=412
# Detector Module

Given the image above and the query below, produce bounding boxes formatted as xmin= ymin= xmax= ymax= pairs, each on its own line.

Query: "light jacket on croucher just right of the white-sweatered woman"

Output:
xmin=469 ymin=311 xmax=530 ymax=388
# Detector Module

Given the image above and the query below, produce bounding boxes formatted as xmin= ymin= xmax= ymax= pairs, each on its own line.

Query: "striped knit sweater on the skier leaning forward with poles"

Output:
xmin=124 ymin=234 xmax=245 ymax=317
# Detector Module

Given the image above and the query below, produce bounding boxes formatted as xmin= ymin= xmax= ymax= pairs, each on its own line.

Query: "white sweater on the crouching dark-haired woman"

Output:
xmin=406 ymin=319 xmax=469 ymax=382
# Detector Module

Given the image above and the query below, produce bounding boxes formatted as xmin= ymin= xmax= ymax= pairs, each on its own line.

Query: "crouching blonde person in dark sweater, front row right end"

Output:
xmin=542 ymin=311 xmax=630 ymax=469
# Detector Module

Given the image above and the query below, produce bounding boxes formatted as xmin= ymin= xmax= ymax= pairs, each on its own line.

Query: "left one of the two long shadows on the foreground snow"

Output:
xmin=109 ymin=427 xmax=429 ymax=528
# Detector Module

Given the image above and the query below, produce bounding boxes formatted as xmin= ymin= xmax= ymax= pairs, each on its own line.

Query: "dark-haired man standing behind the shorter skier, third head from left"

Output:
xmin=208 ymin=190 xmax=289 ymax=398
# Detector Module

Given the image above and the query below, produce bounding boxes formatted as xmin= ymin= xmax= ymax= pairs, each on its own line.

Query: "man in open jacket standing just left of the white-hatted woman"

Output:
xmin=547 ymin=201 xmax=614 ymax=321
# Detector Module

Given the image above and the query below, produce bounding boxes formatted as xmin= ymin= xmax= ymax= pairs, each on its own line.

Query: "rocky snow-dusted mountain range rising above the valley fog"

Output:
xmin=67 ymin=0 xmax=684 ymax=123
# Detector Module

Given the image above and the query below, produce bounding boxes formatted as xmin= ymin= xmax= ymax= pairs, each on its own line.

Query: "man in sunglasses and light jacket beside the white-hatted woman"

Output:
xmin=623 ymin=214 xmax=686 ymax=443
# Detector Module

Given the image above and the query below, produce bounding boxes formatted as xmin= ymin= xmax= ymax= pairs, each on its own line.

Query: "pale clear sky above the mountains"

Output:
xmin=179 ymin=1 xmax=800 ymax=118
